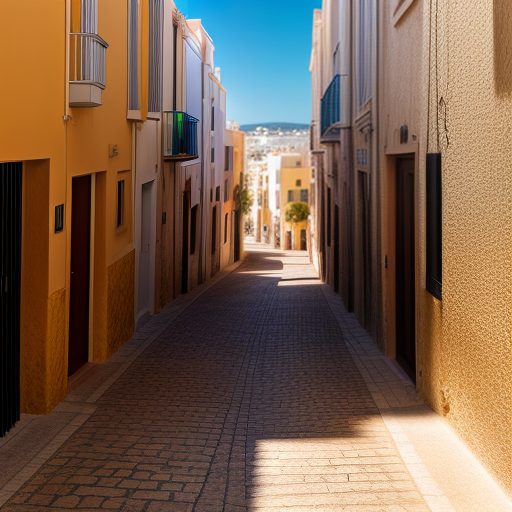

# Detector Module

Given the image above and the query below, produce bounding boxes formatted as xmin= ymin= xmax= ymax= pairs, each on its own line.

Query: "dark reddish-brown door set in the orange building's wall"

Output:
xmin=68 ymin=176 xmax=91 ymax=375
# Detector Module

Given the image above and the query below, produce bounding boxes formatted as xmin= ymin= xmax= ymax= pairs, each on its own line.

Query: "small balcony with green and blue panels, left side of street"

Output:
xmin=162 ymin=111 xmax=199 ymax=162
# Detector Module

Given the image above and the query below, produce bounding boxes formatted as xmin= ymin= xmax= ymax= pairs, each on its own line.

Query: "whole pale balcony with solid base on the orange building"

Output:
xmin=69 ymin=32 xmax=108 ymax=107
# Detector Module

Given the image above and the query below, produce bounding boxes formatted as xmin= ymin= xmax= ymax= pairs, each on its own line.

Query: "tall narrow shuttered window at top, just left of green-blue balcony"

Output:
xmin=148 ymin=0 xmax=164 ymax=113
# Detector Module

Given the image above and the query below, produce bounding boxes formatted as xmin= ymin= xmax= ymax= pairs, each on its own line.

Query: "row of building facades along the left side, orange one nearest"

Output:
xmin=0 ymin=0 xmax=243 ymax=435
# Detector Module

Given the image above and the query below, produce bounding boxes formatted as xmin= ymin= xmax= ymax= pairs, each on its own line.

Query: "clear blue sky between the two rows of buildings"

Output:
xmin=176 ymin=0 xmax=321 ymax=124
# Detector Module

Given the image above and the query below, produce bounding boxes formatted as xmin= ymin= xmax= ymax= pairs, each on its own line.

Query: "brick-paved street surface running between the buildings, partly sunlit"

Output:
xmin=1 ymin=251 xmax=429 ymax=512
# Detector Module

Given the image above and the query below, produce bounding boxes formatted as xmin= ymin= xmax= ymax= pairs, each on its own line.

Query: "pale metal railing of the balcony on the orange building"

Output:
xmin=69 ymin=32 xmax=108 ymax=89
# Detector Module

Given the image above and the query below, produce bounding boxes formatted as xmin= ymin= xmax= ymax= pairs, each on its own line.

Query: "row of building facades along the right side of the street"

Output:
xmin=311 ymin=0 xmax=512 ymax=491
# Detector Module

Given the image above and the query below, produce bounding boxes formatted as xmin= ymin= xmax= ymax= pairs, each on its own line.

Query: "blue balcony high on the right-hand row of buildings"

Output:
xmin=320 ymin=75 xmax=350 ymax=144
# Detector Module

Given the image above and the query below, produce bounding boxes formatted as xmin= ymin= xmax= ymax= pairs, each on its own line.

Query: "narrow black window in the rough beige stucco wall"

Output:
xmin=426 ymin=153 xmax=443 ymax=300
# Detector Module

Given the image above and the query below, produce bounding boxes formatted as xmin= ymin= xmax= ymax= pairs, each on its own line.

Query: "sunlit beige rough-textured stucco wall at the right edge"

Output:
xmin=424 ymin=0 xmax=512 ymax=491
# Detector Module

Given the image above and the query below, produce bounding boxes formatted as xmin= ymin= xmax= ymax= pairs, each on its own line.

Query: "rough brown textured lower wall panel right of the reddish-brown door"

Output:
xmin=107 ymin=250 xmax=135 ymax=357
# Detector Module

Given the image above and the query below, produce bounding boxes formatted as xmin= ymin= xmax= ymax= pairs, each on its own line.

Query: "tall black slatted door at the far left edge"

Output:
xmin=0 ymin=162 xmax=22 ymax=436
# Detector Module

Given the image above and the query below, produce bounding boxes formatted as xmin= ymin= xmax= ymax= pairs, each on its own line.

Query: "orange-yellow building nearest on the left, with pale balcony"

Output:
xmin=0 ymin=0 xmax=139 ymax=430
